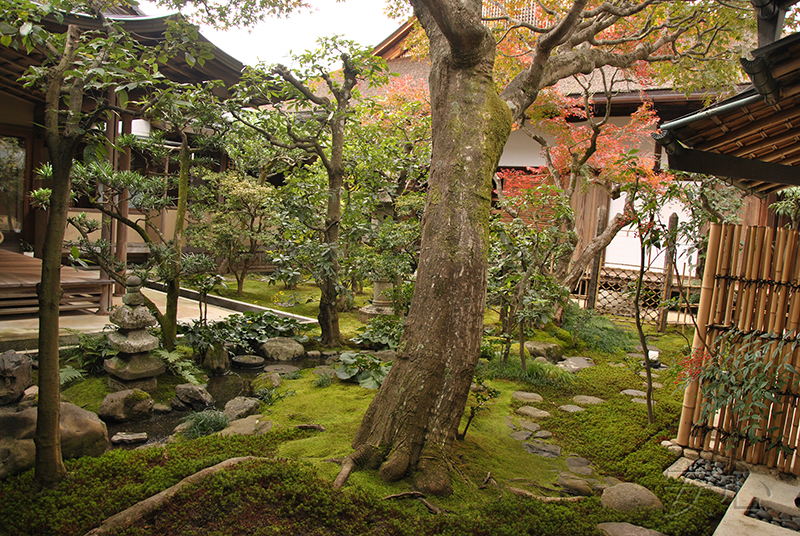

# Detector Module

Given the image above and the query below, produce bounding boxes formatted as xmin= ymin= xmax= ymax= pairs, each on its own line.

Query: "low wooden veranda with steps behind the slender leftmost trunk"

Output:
xmin=0 ymin=249 xmax=113 ymax=315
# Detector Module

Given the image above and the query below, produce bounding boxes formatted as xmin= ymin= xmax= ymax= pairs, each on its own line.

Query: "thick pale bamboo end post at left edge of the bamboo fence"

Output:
xmin=678 ymin=224 xmax=722 ymax=446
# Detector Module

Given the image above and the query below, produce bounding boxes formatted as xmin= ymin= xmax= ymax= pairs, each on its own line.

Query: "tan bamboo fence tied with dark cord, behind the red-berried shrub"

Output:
xmin=678 ymin=225 xmax=800 ymax=475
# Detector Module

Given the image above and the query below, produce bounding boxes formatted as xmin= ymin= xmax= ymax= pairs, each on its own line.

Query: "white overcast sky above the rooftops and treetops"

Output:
xmin=140 ymin=0 xmax=401 ymax=65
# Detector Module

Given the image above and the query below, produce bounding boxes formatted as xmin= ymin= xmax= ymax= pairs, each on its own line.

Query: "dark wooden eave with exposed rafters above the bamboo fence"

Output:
xmin=654 ymin=33 xmax=800 ymax=196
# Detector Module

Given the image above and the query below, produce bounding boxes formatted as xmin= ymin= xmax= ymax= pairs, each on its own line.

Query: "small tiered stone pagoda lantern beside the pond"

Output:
xmin=103 ymin=276 xmax=165 ymax=393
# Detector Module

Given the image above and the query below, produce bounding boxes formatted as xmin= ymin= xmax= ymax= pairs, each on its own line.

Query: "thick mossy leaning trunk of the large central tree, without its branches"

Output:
xmin=339 ymin=2 xmax=511 ymax=493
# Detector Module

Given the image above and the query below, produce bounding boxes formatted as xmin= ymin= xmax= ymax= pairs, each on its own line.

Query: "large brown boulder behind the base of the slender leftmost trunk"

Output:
xmin=0 ymin=402 xmax=109 ymax=478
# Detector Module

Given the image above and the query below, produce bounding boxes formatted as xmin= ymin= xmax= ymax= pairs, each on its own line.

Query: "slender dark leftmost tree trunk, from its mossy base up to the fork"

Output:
xmin=34 ymin=141 xmax=74 ymax=488
